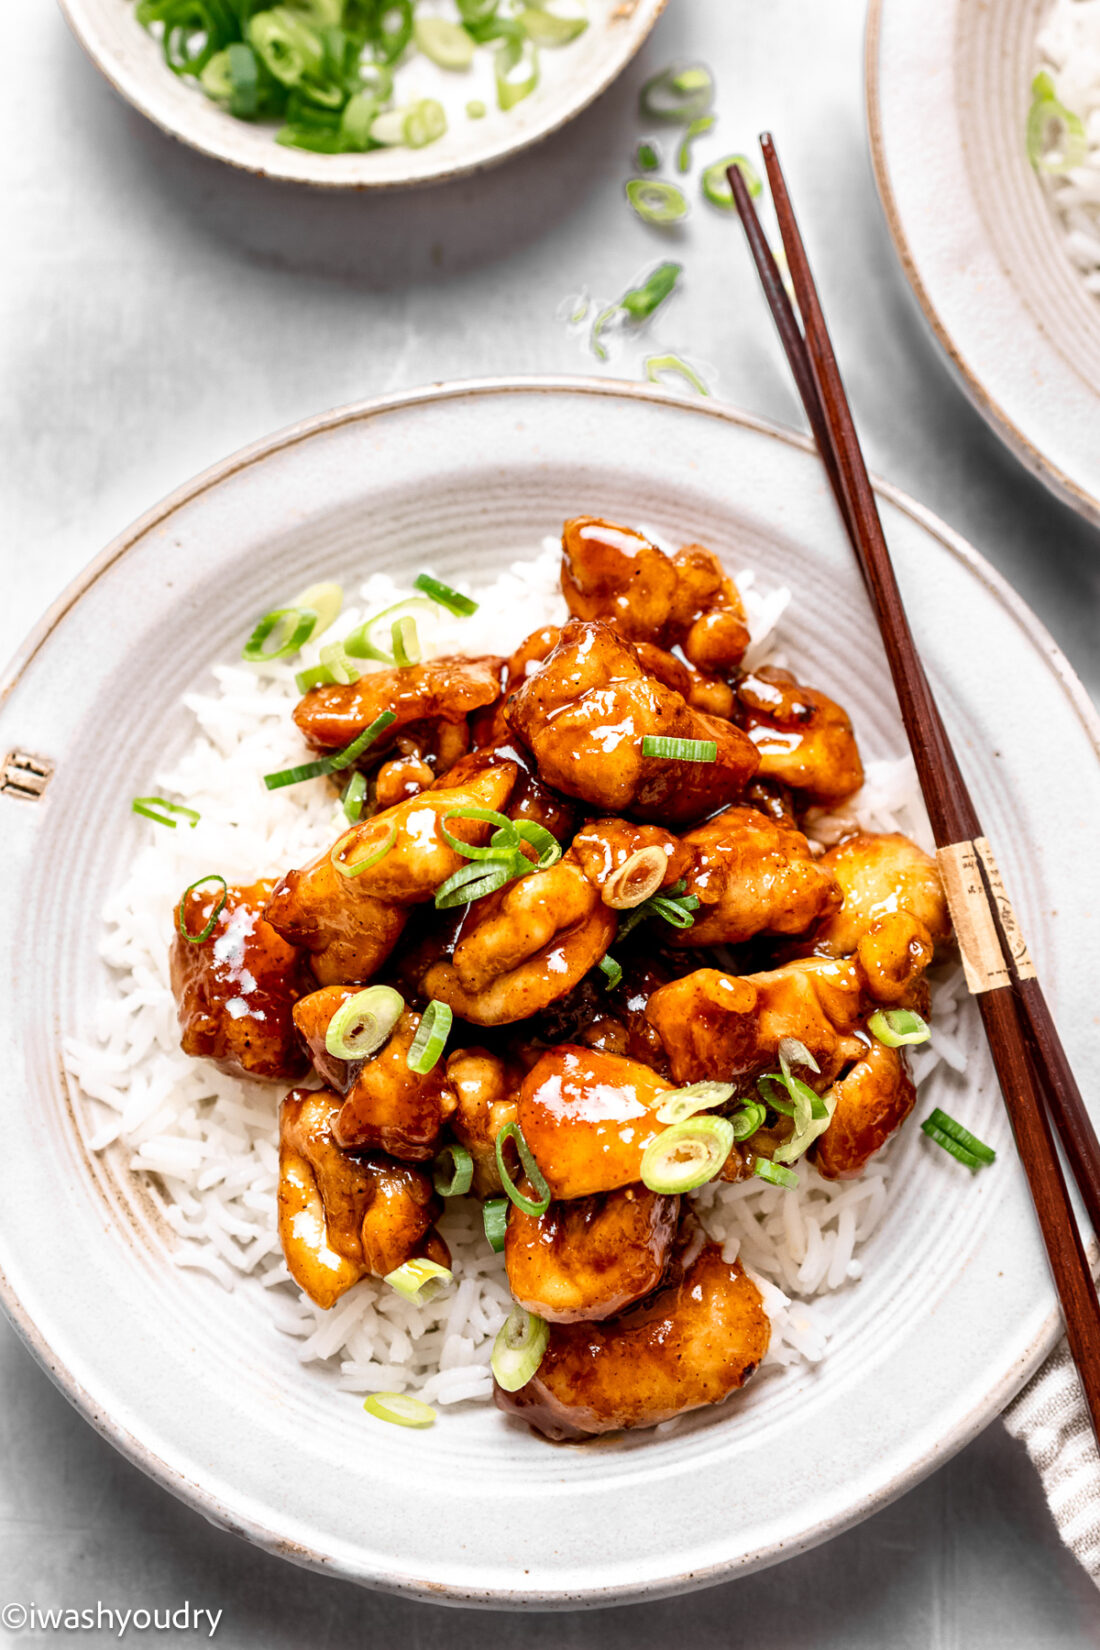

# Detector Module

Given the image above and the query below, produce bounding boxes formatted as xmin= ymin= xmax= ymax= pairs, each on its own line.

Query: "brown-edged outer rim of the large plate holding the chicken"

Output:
xmin=0 ymin=375 xmax=1100 ymax=1610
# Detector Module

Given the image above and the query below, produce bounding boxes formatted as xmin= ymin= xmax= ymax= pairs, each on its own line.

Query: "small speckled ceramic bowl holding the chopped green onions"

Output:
xmin=59 ymin=0 xmax=666 ymax=190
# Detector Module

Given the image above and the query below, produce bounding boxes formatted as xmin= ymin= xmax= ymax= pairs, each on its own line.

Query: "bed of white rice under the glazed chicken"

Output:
xmin=64 ymin=540 xmax=963 ymax=1404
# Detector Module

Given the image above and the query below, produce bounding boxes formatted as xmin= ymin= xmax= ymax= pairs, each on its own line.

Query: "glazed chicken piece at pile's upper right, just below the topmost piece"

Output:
xmin=737 ymin=665 xmax=863 ymax=805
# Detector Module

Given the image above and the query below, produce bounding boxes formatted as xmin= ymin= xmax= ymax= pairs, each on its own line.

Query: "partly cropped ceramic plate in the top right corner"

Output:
xmin=866 ymin=0 xmax=1100 ymax=521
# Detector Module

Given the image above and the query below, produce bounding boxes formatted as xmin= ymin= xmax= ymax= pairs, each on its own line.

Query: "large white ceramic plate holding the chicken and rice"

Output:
xmin=0 ymin=381 xmax=1100 ymax=1605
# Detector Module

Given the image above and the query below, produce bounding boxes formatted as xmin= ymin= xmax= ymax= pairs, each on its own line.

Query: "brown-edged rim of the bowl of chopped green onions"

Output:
xmin=58 ymin=0 xmax=668 ymax=195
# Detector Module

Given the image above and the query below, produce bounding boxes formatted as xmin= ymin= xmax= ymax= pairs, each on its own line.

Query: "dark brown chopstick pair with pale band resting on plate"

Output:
xmin=727 ymin=132 xmax=1100 ymax=1440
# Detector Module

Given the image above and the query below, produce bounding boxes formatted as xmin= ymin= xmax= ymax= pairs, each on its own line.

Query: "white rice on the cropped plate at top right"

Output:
xmin=1036 ymin=0 xmax=1100 ymax=297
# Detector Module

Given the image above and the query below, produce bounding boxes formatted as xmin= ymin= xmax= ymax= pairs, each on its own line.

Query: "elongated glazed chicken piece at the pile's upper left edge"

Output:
xmin=294 ymin=658 xmax=503 ymax=761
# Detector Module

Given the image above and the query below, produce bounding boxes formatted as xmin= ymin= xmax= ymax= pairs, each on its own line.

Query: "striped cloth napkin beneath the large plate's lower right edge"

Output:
xmin=1004 ymin=1341 xmax=1100 ymax=1587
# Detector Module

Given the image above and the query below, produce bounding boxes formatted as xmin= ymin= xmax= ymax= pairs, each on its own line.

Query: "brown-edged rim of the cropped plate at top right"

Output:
xmin=863 ymin=0 xmax=1100 ymax=525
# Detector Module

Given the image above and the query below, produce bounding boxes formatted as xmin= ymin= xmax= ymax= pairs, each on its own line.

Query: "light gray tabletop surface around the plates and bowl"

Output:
xmin=0 ymin=0 xmax=1100 ymax=1650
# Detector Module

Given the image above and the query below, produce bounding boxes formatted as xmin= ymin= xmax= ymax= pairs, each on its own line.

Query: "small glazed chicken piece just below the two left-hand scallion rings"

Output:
xmin=333 ymin=1008 xmax=458 ymax=1163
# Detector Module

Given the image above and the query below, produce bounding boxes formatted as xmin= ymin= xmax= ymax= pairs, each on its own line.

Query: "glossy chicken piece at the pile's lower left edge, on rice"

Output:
xmin=279 ymin=1089 xmax=450 ymax=1308
